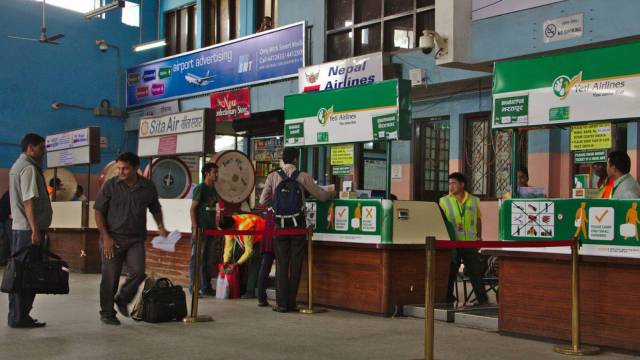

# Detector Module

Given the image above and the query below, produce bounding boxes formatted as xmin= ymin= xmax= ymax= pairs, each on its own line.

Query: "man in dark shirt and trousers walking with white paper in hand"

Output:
xmin=93 ymin=152 xmax=167 ymax=325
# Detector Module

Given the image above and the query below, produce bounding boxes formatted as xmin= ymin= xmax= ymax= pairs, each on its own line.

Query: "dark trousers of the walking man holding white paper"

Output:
xmin=100 ymin=239 xmax=146 ymax=316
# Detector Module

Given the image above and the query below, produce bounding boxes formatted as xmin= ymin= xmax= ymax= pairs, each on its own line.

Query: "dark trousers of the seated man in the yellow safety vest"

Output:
xmin=447 ymin=249 xmax=489 ymax=303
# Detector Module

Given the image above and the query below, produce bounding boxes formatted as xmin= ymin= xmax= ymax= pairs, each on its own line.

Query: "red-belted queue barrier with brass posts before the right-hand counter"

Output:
xmin=424 ymin=236 xmax=600 ymax=360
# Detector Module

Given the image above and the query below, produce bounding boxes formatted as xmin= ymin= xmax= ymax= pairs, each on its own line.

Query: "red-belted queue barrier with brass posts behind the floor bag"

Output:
xmin=196 ymin=228 xmax=327 ymax=319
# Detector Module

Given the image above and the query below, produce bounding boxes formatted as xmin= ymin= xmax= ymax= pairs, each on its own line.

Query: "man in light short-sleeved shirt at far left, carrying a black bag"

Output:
xmin=8 ymin=134 xmax=53 ymax=328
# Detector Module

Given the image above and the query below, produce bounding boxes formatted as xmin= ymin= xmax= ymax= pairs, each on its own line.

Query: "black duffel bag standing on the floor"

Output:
xmin=142 ymin=278 xmax=187 ymax=323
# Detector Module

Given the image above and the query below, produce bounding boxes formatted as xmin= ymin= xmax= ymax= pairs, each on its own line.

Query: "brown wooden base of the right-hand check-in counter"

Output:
xmin=483 ymin=250 xmax=640 ymax=351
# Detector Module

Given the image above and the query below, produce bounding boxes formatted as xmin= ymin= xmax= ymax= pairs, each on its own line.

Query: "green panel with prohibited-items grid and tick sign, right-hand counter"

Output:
xmin=499 ymin=199 xmax=640 ymax=258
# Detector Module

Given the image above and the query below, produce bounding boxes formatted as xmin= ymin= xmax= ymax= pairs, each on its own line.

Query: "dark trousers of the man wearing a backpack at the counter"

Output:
xmin=273 ymin=218 xmax=307 ymax=310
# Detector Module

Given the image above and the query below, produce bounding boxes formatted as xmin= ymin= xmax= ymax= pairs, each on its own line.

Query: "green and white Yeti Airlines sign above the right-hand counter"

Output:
xmin=493 ymin=42 xmax=640 ymax=129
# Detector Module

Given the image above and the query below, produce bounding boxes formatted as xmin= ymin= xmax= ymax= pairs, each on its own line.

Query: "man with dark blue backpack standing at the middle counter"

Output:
xmin=260 ymin=147 xmax=332 ymax=312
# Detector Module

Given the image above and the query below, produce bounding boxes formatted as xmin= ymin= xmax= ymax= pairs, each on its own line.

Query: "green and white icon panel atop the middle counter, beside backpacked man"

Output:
xmin=307 ymin=199 xmax=393 ymax=244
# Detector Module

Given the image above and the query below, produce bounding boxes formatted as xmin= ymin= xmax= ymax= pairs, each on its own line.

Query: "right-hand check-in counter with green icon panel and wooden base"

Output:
xmin=490 ymin=199 xmax=640 ymax=351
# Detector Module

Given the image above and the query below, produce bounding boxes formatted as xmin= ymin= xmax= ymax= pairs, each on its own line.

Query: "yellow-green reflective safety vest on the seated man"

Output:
xmin=439 ymin=193 xmax=480 ymax=241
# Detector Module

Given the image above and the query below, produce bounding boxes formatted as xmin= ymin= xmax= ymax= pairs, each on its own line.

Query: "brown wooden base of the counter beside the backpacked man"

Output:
xmin=298 ymin=241 xmax=451 ymax=316
